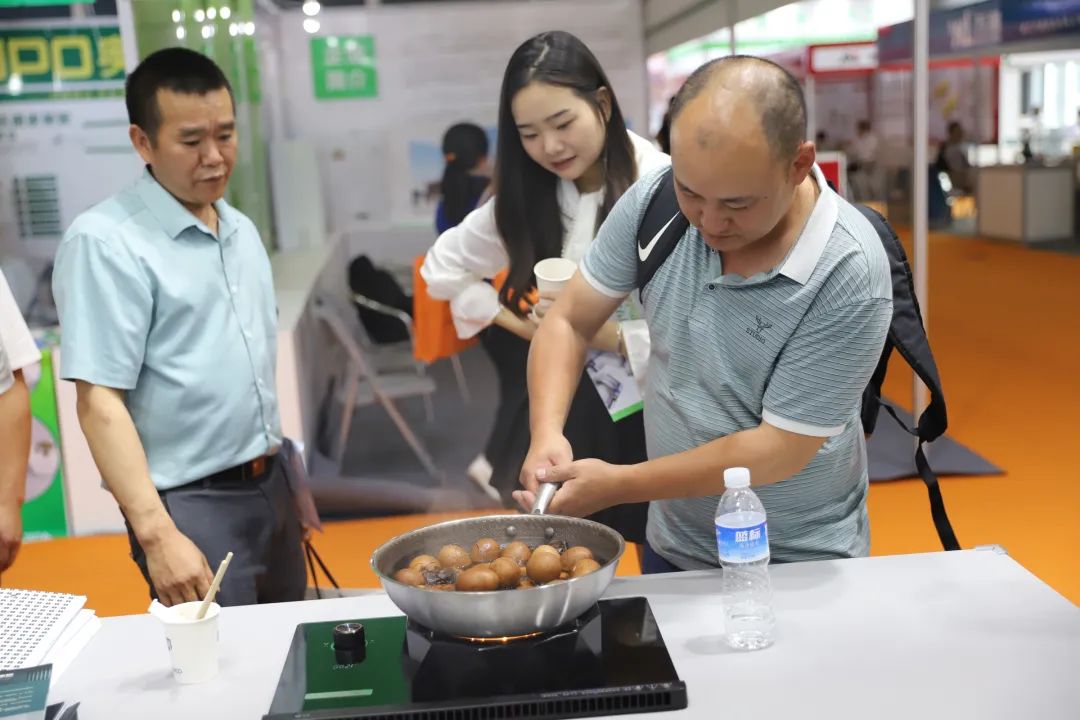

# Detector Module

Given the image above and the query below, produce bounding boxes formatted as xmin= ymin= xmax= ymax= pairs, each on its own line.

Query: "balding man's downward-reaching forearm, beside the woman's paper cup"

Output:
xmin=528 ymin=314 xmax=585 ymax=438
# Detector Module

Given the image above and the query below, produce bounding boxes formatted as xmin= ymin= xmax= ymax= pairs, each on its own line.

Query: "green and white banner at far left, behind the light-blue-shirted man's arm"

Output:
xmin=23 ymin=348 xmax=67 ymax=540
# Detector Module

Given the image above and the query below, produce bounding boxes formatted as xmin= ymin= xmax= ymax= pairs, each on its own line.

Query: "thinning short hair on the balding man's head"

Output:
xmin=671 ymin=55 xmax=807 ymax=160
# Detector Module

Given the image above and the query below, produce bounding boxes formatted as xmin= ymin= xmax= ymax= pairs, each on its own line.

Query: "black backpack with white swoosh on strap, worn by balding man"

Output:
xmin=637 ymin=168 xmax=960 ymax=551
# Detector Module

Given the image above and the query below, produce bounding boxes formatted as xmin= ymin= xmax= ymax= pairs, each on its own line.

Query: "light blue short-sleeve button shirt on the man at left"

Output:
xmin=53 ymin=171 xmax=281 ymax=490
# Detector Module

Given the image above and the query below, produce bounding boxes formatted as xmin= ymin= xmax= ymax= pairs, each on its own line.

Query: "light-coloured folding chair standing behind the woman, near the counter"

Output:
xmin=313 ymin=294 xmax=445 ymax=484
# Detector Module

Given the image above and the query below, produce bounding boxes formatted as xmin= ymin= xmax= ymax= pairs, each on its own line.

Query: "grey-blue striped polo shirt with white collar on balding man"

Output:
xmin=581 ymin=166 xmax=892 ymax=569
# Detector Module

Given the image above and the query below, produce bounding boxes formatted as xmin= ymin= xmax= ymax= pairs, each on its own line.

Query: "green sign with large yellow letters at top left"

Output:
xmin=0 ymin=26 xmax=124 ymax=100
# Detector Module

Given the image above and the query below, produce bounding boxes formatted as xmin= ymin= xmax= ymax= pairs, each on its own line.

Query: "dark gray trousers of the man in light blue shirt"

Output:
xmin=127 ymin=462 xmax=307 ymax=607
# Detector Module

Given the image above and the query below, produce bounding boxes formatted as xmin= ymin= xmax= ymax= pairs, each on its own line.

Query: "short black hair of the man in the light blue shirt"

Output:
xmin=124 ymin=47 xmax=235 ymax=140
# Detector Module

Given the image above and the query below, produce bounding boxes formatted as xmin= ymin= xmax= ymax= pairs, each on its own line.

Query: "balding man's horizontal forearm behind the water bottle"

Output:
xmin=619 ymin=425 xmax=824 ymax=502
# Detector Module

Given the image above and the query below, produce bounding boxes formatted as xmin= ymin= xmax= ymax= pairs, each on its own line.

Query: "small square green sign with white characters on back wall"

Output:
xmin=311 ymin=35 xmax=379 ymax=100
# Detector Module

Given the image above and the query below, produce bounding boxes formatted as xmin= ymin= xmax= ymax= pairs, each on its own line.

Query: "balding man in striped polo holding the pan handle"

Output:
xmin=517 ymin=57 xmax=892 ymax=572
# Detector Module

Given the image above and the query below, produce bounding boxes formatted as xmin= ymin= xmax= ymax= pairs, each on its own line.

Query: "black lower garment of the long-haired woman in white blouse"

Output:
xmin=481 ymin=325 xmax=649 ymax=543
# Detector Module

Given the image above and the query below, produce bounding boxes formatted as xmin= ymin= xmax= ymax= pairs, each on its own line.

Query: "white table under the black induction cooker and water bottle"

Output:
xmin=50 ymin=549 xmax=1080 ymax=720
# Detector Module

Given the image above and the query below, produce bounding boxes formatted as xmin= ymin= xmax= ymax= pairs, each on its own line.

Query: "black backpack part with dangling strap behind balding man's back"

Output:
xmin=855 ymin=205 xmax=960 ymax=551
